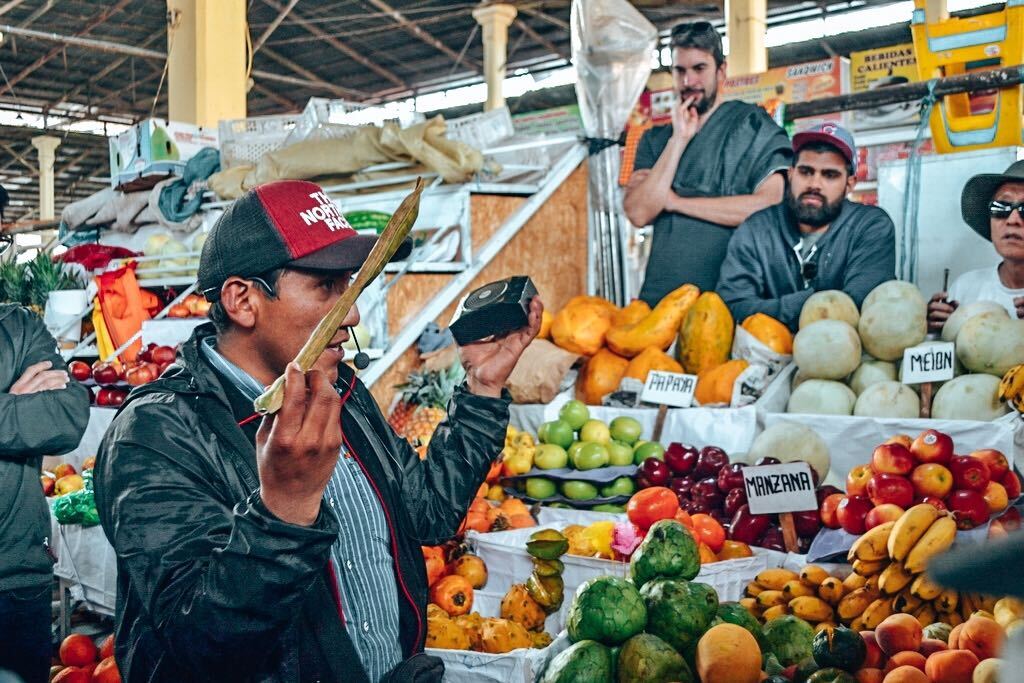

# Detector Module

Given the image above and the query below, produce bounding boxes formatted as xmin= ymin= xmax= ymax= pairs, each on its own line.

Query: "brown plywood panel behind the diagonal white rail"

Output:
xmin=372 ymin=164 xmax=587 ymax=413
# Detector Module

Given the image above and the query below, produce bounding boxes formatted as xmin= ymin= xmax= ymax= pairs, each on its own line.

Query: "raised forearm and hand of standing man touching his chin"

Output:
xmin=623 ymin=97 xmax=700 ymax=227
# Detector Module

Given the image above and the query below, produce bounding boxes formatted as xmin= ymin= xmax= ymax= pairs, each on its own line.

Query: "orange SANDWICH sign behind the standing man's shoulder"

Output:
xmin=722 ymin=57 xmax=850 ymax=133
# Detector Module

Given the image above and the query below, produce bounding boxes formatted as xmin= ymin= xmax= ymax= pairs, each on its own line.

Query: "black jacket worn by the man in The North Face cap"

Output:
xmin=95 ymin=326 xmax=508 ymax=683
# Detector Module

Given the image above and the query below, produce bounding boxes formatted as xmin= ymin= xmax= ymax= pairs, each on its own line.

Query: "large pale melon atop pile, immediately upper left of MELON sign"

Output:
xmin=857 ymin=294 xmax=928 ymax=360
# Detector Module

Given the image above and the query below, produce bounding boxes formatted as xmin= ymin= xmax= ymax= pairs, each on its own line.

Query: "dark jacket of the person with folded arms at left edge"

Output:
xmin=0 ymin=304 xmax=89 ymax=592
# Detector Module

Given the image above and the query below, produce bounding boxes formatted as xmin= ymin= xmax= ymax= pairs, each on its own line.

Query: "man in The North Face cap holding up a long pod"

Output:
xmin=96 ymin=180 xmax=543 ymax=682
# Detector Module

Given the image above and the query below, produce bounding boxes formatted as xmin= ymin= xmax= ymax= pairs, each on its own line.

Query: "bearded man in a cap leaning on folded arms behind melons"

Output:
xmin=715 ymin=123 xmax=896 ymax=332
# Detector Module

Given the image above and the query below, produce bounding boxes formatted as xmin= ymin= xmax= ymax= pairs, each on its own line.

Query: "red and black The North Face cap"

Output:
xmin=199 ymin=180 xmax=412 ymax=301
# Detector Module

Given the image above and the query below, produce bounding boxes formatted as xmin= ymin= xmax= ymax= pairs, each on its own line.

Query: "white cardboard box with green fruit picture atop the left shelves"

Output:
xmin=108 ymin=119 xmax=218 ymax=189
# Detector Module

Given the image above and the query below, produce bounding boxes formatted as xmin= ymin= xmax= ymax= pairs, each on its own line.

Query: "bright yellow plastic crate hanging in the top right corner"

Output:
xmin=910 ymin=0 xmax=1024 ymax=153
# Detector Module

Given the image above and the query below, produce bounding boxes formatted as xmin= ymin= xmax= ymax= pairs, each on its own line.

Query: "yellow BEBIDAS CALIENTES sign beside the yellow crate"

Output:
xmin=850 ymin=43 xmax=921 ymax=130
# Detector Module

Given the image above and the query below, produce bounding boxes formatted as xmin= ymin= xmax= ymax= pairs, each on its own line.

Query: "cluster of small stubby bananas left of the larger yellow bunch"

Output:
xmin=739 ymin=564 xmax=852 ymax=631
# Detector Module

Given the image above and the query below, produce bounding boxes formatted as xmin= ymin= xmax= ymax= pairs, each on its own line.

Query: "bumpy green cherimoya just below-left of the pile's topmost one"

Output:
xmin=565 ymin=577 xmax=647 ymax=645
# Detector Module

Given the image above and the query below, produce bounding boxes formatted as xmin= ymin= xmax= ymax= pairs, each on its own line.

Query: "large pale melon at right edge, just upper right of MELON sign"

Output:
xmin=956 ymin=311 xmax=1024 ymax=377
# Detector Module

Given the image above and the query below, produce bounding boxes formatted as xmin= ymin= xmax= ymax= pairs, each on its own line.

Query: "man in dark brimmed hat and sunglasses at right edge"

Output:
xmin=928 ymin=161 xmax=1024 ymax=332
